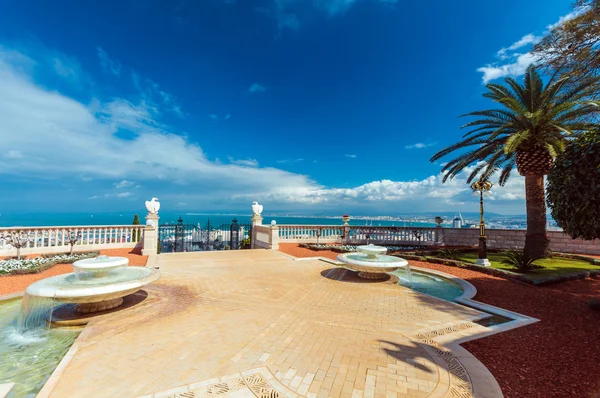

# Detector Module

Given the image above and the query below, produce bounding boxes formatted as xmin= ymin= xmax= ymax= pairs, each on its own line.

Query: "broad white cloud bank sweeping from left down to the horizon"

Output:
xmin=0 ymin=41 xmax=524 ymax=215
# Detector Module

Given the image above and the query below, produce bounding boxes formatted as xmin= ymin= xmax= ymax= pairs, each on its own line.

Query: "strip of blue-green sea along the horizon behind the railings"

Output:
xmin=0 ymin=212 xmax=436 ymax=227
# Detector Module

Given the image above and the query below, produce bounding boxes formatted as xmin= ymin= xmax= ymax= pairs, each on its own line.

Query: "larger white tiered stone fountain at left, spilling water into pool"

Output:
xmin=25 ymin=256 xmax=160 ymax=314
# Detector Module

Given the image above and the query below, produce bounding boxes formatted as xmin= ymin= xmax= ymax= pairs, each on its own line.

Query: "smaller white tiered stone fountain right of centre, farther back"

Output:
xmin=337 ymin=245 xmax=410 ymax=279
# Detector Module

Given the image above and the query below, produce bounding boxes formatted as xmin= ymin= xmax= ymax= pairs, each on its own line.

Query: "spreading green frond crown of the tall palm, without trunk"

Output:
xmin=431 ymin=65 xmax=600 ymax=185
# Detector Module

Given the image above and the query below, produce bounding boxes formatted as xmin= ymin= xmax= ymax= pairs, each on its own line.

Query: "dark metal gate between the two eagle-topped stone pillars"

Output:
xmin=158 ymin=217 xmax=252 ymax=253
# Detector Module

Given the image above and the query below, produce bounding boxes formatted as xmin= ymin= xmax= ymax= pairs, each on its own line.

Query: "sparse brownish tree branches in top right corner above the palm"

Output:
xmin=533 ymin=0 xmax=600 ymax=82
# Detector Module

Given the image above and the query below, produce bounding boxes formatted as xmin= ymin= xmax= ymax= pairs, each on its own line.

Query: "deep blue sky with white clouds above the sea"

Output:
xmin=0 ymin=0 xmax=571 ymax=214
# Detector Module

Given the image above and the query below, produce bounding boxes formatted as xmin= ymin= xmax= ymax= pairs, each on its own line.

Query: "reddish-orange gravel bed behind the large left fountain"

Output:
xmin=0 ymin=249 xmax=148 ymax=296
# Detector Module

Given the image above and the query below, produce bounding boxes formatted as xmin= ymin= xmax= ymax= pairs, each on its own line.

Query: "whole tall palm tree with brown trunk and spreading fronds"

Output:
xmin=431 ymin=65 xmax=600 ymax=258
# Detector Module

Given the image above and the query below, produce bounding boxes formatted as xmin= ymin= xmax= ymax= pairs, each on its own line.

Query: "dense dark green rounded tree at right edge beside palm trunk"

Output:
xmin=547 ymin=131 xmax=600 ymax=240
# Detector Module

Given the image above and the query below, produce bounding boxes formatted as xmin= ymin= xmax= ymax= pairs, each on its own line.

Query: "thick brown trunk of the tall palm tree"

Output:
xmin=524 ymin=174 xmax=551 ymax=258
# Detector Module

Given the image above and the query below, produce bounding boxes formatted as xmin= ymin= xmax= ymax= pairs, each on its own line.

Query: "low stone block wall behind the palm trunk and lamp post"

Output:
xmin=442 ymin=228 xmax=600 ymax=254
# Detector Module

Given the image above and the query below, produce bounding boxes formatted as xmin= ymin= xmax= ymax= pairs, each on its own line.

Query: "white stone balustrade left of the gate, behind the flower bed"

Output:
xmin=0 ymin=225 xmax=145 ymax=256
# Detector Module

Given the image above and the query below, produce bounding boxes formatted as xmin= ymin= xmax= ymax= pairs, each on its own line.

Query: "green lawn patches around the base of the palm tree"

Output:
xmin=458 ymin=252 xmax=600 ymax=279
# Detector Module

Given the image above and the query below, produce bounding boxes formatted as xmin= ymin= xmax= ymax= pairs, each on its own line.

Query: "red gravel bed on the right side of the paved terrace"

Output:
xmin=280 ymin=244 xmax=600 ymax=398
